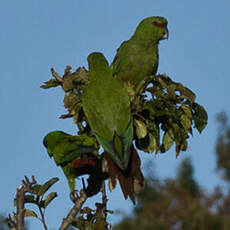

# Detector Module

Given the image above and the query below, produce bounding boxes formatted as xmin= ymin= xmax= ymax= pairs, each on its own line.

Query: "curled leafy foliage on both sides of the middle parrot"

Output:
xmin=41 ymin=66 xmax=208 ymax=158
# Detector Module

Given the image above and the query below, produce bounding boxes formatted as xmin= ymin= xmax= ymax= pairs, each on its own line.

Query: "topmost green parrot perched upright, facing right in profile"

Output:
xmin=111 ymin=17 xmax=168 ymax=92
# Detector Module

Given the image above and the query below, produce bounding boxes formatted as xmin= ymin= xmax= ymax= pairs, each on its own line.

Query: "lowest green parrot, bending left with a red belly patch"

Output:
xmin=43 ymin=131 xmax=103 ymax=196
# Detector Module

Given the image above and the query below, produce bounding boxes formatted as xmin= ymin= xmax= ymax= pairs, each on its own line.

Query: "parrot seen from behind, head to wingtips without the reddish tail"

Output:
xmin=82 ymin=52 xmax=133 ymax=170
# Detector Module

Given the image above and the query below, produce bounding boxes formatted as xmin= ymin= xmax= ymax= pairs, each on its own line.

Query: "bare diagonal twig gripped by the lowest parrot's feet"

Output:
xmin=59 ymin=189 xmax=87 ymax=230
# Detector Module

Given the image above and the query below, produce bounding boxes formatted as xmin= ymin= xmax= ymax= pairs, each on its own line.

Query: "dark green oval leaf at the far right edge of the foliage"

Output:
xmin=192 ymin=103 xmax=208 ymax=133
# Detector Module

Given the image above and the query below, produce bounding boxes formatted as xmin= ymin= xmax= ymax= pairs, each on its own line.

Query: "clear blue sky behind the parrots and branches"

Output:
xmin=0 ymin=0 xmax=230 ymax=230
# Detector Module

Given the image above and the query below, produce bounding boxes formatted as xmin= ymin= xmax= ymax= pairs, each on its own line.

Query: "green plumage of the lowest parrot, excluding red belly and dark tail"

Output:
xmin=43 ymin=131 xmax=98 ymax=191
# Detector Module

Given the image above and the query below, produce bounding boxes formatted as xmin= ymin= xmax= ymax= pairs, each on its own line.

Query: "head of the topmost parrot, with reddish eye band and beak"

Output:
xmin=134 ymin=17 xmax=168 ymax=42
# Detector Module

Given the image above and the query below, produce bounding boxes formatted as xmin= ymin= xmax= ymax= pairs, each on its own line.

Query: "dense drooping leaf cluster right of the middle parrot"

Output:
xmin=132 ymin=74 xmax=208 ymax=155
